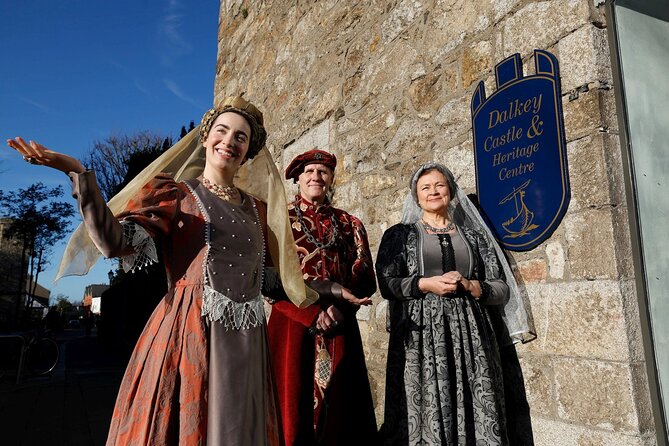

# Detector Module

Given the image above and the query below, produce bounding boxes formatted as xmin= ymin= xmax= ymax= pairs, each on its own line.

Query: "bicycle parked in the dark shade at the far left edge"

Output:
xmin=0 ymin=331 xmax=60 ymax=384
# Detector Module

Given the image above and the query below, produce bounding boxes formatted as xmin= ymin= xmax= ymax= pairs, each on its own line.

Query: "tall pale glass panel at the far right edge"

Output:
xmin=614 ymin=0 xmax=669 ymax=432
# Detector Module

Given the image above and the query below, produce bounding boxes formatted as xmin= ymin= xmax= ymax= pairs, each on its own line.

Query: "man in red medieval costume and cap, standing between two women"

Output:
xmin=268 ymin=150 xmax=377 ymax=446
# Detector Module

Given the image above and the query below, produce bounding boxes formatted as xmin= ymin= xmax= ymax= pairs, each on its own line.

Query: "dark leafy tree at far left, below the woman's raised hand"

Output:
xmin=0 ymin=183 xmax=74 ymax=320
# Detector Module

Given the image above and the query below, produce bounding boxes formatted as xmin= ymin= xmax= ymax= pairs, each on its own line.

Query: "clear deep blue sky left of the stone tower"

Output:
xmin=0 ymin=0 xmax=219 ymax=301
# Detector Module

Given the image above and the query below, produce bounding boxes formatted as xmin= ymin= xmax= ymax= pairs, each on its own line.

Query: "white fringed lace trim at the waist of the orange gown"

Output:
xmin=202 ymin=285 xmax=265 ymax=330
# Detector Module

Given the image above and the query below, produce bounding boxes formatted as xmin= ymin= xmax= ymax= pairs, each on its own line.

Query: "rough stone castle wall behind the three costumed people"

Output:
xmin=215 ymin=0 xmax=654 ymax=446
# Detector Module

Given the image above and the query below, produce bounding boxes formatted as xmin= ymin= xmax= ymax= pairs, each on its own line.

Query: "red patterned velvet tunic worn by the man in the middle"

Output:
xmin=268 ymin=197 xmax=376 ymax=446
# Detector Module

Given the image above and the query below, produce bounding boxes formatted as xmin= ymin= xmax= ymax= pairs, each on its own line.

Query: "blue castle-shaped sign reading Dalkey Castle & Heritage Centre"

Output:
xmin=472 ymin=50 xmax=570 ymax=251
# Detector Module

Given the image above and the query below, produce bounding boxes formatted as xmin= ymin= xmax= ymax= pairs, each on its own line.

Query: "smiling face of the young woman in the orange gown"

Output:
xmin=203 ymin=112 xmax=251 ymax=172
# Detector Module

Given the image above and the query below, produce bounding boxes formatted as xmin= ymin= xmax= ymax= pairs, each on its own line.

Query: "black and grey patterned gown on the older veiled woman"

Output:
xmin=376 ymin=224 xmax=508 ymax=446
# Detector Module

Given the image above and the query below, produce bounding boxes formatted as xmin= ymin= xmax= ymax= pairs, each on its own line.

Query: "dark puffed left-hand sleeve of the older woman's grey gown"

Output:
xmin=376 ymin=225 xmax=424 ymax=300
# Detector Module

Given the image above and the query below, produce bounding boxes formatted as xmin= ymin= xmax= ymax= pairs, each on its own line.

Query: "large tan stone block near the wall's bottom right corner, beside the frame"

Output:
xmin=554 ymin=358 xmax=639 ymax=435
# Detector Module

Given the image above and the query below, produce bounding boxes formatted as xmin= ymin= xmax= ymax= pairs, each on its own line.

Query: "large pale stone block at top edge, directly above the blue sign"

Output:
xmin=501 ymin=0 xmax=590 ymax=58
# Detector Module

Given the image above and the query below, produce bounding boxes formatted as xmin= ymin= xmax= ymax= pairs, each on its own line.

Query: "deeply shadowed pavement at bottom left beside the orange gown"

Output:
xmin=0 ymin=329 xmax=125 ymax=446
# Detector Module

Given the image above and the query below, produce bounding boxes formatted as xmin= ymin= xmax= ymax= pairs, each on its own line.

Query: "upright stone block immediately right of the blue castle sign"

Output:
xmin=567 ymin=134 xmax=611 ymax=210
